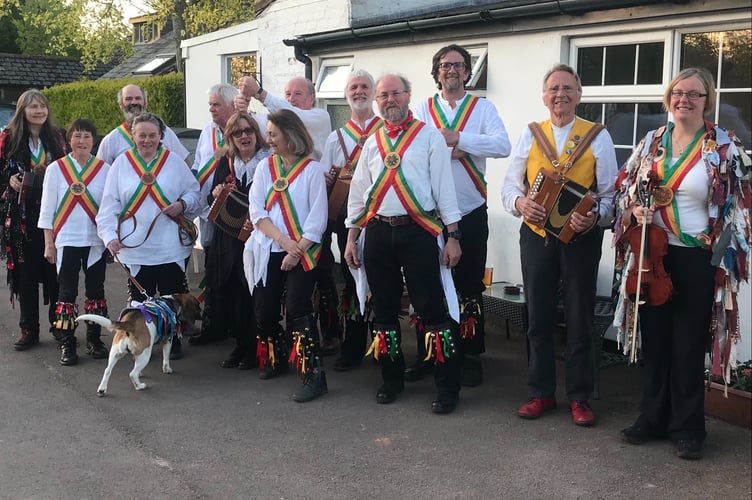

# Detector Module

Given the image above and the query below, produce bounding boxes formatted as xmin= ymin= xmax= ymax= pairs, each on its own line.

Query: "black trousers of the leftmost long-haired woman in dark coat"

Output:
xmin=16 ymin=237 xmax=58 ymax=333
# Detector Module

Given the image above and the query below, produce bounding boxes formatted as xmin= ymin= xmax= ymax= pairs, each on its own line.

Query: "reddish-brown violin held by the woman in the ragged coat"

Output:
xmin=625 ymin=171 xmax=673 ymax=308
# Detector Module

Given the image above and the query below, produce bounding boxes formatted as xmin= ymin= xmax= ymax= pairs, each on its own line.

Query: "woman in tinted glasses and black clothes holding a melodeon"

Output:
xmin=206 ymin=113 xmax=271 ymax=370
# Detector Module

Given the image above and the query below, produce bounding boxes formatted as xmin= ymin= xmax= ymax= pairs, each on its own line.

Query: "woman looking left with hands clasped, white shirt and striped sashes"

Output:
xmin=244 ymin=110 xmax=328 ymax=402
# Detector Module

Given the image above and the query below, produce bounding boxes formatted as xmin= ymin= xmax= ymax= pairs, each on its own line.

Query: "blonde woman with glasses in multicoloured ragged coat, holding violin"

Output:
xmin=615 ymin=68 xmax=751 ymax=460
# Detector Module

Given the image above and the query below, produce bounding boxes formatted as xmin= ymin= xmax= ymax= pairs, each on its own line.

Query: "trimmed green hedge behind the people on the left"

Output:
xmin=43 ymin=73 xmax=185 ymax=135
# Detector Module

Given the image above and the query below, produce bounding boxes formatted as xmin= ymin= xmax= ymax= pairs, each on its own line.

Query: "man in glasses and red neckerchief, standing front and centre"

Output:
xmin=345 ymin=75 xmax=462 ymax=413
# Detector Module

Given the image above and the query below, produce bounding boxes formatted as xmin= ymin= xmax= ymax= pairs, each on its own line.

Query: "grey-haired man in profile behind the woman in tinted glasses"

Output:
xmin=188 ymin=83 xmax=238 ymax=345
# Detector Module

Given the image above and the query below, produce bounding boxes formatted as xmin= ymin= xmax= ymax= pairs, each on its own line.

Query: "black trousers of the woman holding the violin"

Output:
xmin=639 ymin=246 xmax=715 ymax=440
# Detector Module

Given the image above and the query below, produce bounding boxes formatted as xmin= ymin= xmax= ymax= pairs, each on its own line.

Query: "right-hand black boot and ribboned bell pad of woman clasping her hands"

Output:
xmin=288 ymin=315 xmax=329 ymax=403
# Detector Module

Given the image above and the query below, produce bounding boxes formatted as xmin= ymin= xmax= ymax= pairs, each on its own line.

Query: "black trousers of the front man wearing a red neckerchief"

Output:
xmin=363 ymin=219 xmax=447 ymax=325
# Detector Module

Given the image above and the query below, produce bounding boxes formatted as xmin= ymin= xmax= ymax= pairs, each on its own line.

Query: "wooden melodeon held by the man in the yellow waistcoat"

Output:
xmin=528 ymin=168 xmax=596 ymax=243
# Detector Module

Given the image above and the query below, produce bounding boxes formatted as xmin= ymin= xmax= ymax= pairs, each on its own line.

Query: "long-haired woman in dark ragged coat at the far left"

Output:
xmin=0 ymin=89 xmax=67 ymax=351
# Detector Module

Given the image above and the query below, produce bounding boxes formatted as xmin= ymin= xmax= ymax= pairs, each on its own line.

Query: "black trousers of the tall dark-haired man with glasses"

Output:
xmin=452 ymin=203 xmax=488 ymax=354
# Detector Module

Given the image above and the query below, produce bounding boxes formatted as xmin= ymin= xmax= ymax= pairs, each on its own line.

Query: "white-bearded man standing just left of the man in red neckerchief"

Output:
xmin=321 ymin=69 xmax=384 ymax=371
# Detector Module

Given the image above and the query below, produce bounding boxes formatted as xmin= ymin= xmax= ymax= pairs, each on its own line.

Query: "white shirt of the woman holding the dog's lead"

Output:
xmin=97 ymin=148 xmax=200 ymax=275
